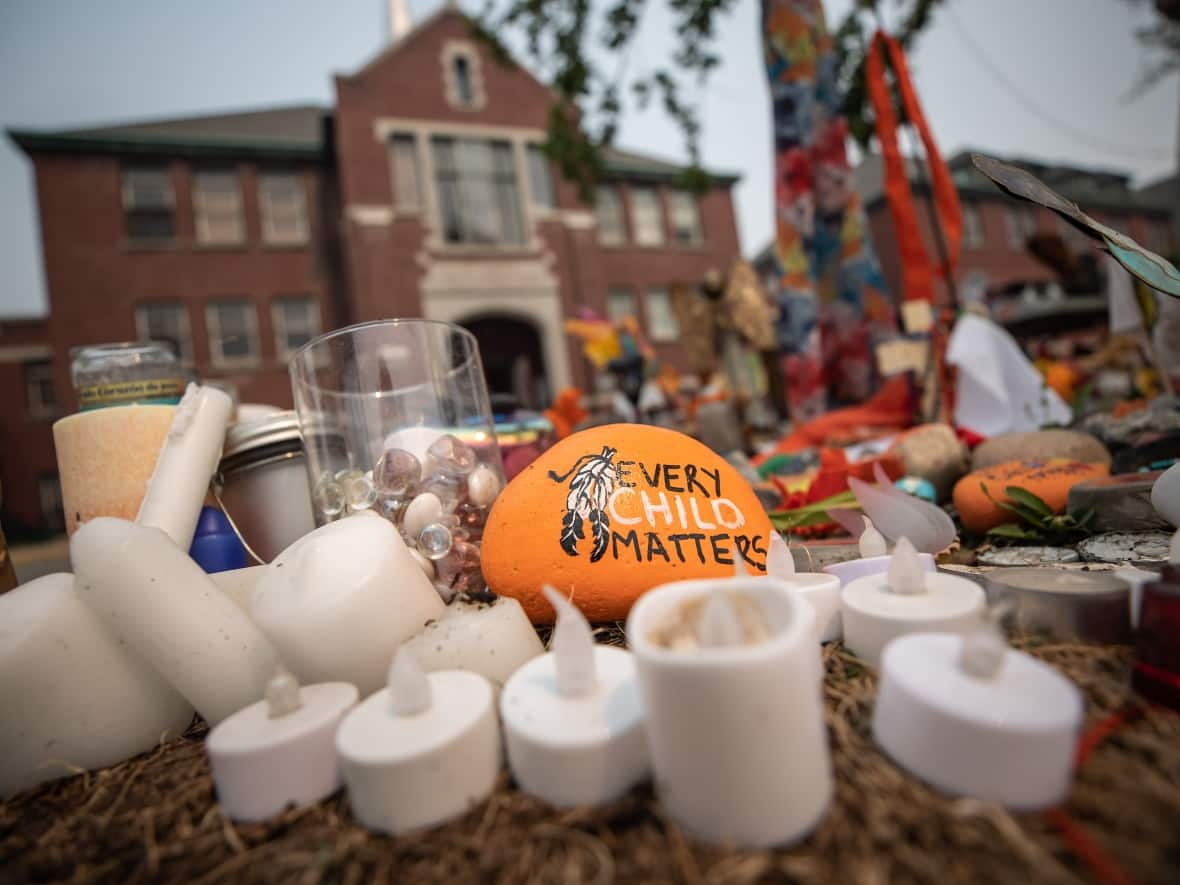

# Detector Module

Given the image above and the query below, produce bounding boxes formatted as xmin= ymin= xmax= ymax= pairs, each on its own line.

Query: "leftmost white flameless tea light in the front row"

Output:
xmin=205 ymin=671 xmax=358 ymax=820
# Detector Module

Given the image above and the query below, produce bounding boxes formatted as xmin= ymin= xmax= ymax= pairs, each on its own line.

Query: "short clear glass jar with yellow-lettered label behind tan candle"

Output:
xmin=70 ymin=341 xmax=184 ymax=412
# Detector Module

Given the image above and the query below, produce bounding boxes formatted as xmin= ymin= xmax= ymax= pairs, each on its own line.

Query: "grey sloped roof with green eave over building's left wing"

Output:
xmin=8 ymin=105 xmax=332 ymax=159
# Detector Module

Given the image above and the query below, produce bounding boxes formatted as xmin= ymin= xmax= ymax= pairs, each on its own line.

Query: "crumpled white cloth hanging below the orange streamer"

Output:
xmin=946 ymin=314 xmax=1074 ymax=437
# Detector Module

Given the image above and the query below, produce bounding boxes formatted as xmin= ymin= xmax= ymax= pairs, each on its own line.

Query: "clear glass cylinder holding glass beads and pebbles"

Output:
xmin=290 ymin=320 xmax=504 ymax=599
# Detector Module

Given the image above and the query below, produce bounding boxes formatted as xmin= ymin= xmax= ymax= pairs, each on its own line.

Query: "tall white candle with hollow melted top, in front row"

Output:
xmin=627 ymin=577 xmax=832 ymax=847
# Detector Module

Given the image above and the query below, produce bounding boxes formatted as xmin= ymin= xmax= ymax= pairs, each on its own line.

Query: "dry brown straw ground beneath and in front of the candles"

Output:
xmin=0 ymin=634 xmax=1180 ymax=885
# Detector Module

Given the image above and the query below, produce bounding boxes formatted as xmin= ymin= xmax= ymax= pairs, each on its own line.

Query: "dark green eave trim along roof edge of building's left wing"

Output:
xmin=7 ymin=129 xmax=327 ymax=160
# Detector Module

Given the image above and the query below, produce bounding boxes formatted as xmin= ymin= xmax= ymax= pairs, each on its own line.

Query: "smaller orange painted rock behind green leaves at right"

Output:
xmin=955 ymin=458 xmax=1110 ymax=532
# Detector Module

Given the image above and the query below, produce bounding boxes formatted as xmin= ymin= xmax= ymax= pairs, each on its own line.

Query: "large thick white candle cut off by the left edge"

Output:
xmin=0 ymin=573 xmax=192 ymax=798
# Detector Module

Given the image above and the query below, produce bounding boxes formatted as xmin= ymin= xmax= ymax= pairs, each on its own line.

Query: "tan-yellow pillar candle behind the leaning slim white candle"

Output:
xmin=53 ymin=405 xmax=176 ymax=535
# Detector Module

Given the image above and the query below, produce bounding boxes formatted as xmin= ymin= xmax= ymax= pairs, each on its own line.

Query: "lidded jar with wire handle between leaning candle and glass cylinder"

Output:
xmin=219 ymin=411 xmax=315 ymax=562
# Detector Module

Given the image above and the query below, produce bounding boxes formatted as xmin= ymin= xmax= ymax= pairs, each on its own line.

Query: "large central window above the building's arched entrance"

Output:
xmin=432 ymin=137 xmax=524 ymax=245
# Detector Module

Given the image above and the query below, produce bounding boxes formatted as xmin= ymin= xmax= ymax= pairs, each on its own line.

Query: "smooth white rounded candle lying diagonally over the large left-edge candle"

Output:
xmin=70 ymin=517 xmax=275 ymax=725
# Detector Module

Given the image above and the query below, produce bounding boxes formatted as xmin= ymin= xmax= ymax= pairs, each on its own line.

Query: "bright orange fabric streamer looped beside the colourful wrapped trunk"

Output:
xmin=865 ymin=31 xmax=963 ymax=302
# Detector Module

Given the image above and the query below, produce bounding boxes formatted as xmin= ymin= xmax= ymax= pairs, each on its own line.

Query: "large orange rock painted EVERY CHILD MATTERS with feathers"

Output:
xmin=480 ymin=424 xmax=772 ymax=623
